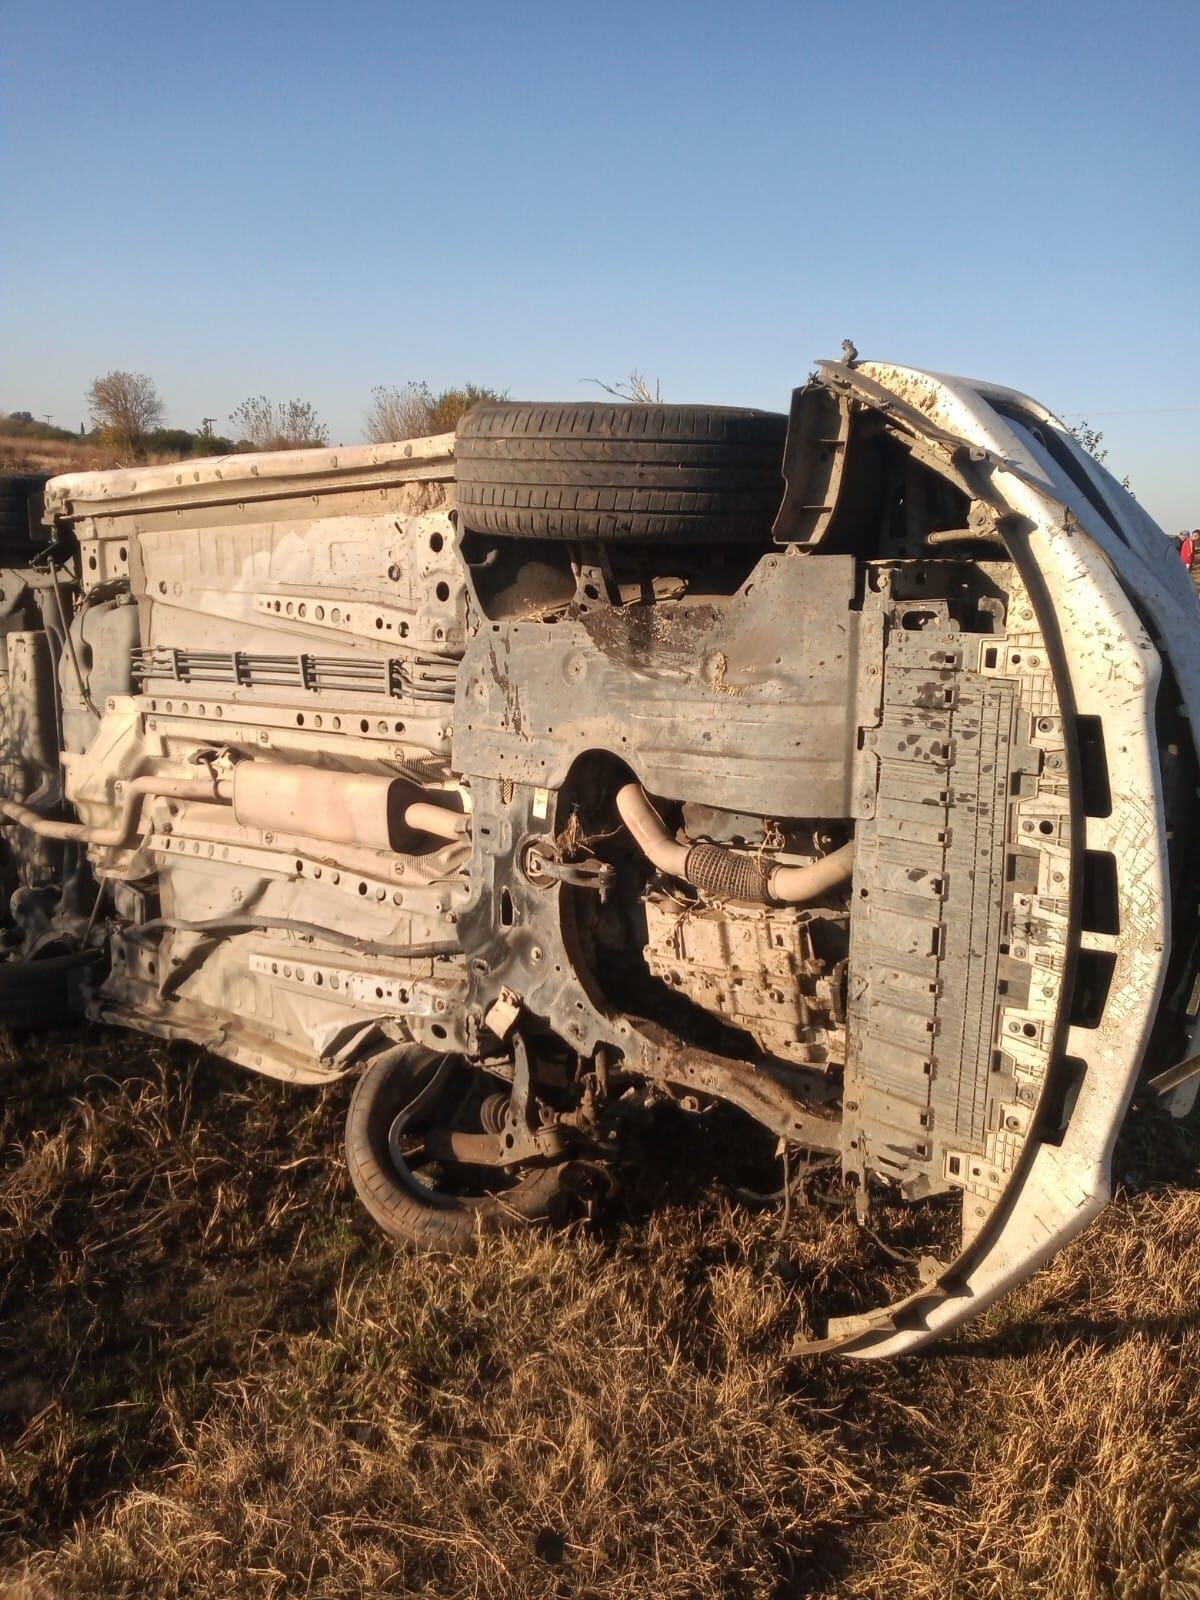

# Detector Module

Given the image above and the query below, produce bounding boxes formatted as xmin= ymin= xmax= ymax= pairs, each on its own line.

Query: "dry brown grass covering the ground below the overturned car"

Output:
xmin=0 ymin=1035 xmax=1200 ymax=1600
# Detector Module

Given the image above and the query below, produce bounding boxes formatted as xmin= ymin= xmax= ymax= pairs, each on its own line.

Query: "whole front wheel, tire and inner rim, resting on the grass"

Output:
xmin=346 ymin=1046 xmax=563 ymax=1253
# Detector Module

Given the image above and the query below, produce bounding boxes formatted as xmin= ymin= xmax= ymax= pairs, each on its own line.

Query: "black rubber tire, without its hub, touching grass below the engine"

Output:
xmin=346 ymin=1045 xmax=562 ymax=1254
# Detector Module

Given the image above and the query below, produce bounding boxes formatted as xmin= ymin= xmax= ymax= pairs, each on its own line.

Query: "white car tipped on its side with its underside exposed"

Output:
xmin=0 ymin=358 xmax=1200 ymax=1355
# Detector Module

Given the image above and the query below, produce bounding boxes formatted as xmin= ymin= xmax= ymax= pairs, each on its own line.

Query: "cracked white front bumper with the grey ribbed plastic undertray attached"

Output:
xmin=797 ymin=365 xmax=1200 ymax=1357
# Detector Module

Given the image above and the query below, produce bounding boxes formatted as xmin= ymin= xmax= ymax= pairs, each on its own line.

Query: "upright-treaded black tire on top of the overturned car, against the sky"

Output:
xmin=454 ymin=402 xmax=787 ymax=544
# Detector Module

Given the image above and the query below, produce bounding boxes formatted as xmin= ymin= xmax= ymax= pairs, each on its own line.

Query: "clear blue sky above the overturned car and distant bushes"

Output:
xmin=0 ymin=0 xmax=1200 ymax=530
